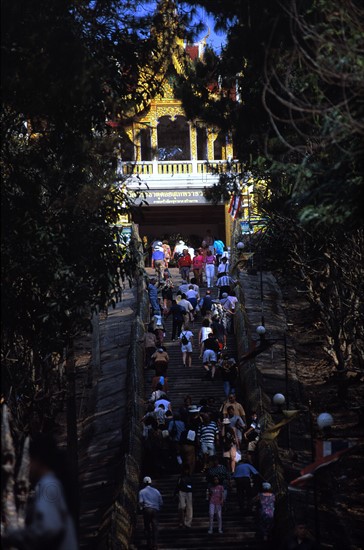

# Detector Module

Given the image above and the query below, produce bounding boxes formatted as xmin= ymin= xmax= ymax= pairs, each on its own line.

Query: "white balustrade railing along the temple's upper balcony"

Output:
xmin=118 ymin=160 xmax=242 ymax=180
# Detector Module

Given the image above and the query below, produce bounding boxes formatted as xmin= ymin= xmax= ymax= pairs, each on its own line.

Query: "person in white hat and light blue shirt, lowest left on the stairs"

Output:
xmin=139 ymin=476 xmax=163 ymax=550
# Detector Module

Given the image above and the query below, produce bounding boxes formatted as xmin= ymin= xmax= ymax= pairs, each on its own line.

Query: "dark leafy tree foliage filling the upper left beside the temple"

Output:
xmin=1 ymin=0 xmax=171 ymax=416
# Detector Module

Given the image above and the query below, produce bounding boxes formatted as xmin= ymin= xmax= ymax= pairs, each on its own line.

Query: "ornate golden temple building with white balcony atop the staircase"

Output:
xmin=119 ymin=7 xmax=239 ymax=244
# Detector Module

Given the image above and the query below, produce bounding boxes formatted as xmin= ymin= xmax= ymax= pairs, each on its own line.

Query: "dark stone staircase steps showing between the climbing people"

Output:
xmin=131 ymin=270 xmax=266 ymax=550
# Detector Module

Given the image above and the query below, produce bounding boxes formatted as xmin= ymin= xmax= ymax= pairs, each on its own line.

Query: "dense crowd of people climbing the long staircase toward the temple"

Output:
xmin=140 ymin=234 xmax=275 ymax=548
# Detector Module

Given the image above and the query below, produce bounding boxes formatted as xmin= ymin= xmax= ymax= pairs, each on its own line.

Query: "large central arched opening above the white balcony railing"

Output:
xmin=157 ymin=116 xmax=191 ymax=160
